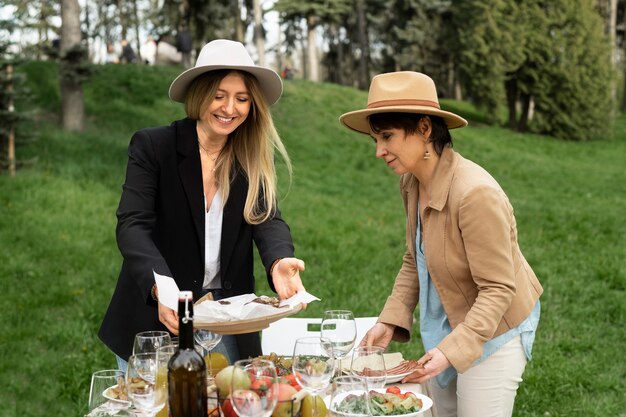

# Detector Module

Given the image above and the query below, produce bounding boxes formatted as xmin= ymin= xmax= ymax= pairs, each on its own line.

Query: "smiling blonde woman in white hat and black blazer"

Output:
xmin=99 ymin=39 xmax=304 ymax=367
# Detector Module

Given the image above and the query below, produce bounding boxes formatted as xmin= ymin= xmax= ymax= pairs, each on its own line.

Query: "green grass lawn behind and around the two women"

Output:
xmin=0 ymin=63 xmax=626 ymax=417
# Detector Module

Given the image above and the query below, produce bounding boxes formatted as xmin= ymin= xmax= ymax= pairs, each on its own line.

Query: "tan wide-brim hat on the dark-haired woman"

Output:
xmin=339 ymin=71 xmax=467 ymax=134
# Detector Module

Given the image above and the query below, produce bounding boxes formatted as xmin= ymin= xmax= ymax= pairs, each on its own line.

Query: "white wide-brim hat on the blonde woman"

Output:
xmin=169 ymin=39 xmax=283 ymax=105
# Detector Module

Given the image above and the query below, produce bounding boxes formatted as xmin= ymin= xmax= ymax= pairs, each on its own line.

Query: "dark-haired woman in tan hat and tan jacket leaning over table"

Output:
xmin=340 ymin=72 xmax=543 ymax=417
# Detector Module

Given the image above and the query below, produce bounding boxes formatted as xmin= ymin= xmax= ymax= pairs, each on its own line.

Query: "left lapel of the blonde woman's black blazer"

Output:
xmin=176 ymin=119 xmax=204 ymax=245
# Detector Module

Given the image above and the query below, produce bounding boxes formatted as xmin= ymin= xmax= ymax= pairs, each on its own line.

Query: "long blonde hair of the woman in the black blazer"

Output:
xmin=185 ymin=70 xmax=292 ymax=224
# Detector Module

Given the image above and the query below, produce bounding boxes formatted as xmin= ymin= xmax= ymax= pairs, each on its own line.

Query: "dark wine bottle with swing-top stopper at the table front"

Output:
xmin=167 ymin=291 xmax=207 ymax=417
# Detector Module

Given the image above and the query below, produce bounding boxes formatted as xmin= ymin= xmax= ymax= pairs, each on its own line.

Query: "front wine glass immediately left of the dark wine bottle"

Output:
xmin=126 ymin=352 xmax=167 ymax=417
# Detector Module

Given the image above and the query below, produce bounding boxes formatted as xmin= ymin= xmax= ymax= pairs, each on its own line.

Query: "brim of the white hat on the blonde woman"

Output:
xmin=169 ymin=65 xmax=283 ymax=106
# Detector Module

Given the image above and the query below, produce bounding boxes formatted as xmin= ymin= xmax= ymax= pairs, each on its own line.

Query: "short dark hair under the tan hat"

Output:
xmin=368 ymin=113 xmax=452 ymax=155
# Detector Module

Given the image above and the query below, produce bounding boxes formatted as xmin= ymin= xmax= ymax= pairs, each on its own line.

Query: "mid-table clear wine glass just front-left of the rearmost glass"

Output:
xmin=291 ymin=337 xmax=335 ymax=417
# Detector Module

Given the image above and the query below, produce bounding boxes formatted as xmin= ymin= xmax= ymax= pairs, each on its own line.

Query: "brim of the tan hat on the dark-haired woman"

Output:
xmin=339 ymin=106 xmax=467 ymax=135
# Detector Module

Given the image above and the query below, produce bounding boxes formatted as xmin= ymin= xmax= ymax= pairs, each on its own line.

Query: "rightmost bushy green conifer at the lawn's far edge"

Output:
xmin=528 ymin=0 xmax=615 ymax=140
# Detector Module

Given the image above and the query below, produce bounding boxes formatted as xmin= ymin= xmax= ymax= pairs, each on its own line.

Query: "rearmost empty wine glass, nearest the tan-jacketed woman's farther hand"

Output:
xmin=320 ymin=310 xmax=356 ymax=374
